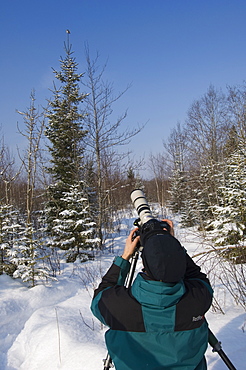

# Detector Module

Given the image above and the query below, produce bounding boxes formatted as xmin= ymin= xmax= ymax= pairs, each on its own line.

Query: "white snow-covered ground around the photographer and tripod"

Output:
xmin=0 ymin=215 xmax=246 ymax=370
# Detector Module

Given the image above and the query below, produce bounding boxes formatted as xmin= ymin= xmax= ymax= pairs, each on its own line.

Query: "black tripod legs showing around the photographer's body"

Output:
xmin=103 ymin=244 xmax=237 ymax=370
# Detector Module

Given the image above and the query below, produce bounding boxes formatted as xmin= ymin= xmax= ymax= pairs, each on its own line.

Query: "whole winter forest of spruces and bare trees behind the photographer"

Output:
xmin=0 ymin=39 xmax=246 ymax=298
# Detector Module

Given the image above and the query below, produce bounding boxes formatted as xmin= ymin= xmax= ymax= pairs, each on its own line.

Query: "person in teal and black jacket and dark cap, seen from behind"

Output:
xmin=91 ymin=220 xmax=212 ymax=370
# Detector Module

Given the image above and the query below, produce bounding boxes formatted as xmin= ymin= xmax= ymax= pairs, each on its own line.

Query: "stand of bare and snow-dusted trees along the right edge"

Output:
xmin=165 ymin=85 xmax=246 ymax=250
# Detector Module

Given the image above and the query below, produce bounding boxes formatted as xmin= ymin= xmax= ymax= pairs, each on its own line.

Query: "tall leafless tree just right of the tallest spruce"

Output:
xmin=84 ymin=46 xmax=142 ymax=247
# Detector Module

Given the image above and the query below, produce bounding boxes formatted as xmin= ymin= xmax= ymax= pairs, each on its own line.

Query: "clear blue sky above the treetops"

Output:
xmin=0 ymin=0 xmax=246 ymax=172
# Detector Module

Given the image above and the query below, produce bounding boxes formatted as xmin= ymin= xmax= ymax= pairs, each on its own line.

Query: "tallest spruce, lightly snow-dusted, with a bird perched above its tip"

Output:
xmin=45 ymin=36 xmax=96 ymax=260
